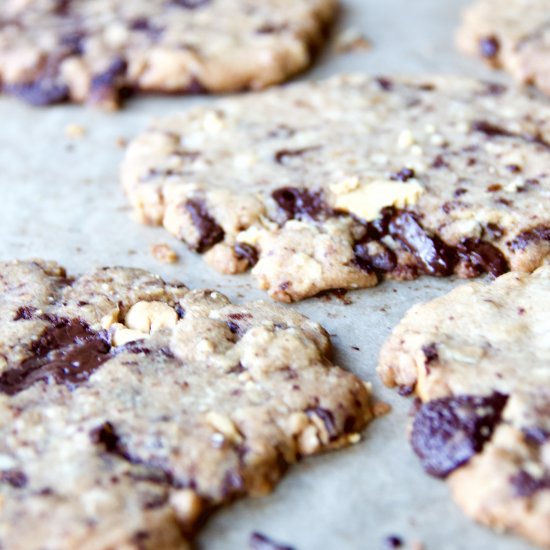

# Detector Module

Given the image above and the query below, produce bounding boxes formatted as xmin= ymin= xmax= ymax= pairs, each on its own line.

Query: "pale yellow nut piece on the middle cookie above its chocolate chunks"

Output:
xmin=335 ymin=180 xmax=424 ymax=221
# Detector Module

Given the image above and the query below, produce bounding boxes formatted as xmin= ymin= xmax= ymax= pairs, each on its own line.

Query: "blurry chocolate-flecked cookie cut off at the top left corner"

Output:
xmin=0 ymin=0 xmax=337 ymax=108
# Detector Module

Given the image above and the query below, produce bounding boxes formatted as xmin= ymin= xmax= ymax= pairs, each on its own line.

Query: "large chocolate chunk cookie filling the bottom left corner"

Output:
xmin=0 ymin=261 xmax=371 ymax=550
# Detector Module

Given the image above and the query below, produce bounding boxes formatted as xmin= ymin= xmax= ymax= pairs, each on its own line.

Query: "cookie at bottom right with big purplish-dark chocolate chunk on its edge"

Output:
xmin=379 ymin=265 xmax=550 ymax=548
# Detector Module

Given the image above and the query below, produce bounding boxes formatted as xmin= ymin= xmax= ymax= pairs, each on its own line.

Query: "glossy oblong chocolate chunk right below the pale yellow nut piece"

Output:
xmin=389 ymin=212 xmax=456 ymax=276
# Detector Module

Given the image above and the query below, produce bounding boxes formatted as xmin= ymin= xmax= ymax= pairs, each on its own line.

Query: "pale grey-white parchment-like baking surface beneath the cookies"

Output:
xmin=0 ymin=0 xmax=531 ymax=550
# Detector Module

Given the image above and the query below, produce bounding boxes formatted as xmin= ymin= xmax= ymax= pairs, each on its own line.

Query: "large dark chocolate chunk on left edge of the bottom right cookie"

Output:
xmin=411 ymin=393 xmax=508 ymax=477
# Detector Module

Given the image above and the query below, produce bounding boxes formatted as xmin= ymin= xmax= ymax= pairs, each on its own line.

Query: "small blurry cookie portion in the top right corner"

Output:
xmin=457 ymin=0 xmax=550 ymax=94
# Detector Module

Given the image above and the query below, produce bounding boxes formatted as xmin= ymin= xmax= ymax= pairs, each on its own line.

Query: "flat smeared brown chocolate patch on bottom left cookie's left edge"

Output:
xmin=0 ymin=317 xmax=111 ymax=395
